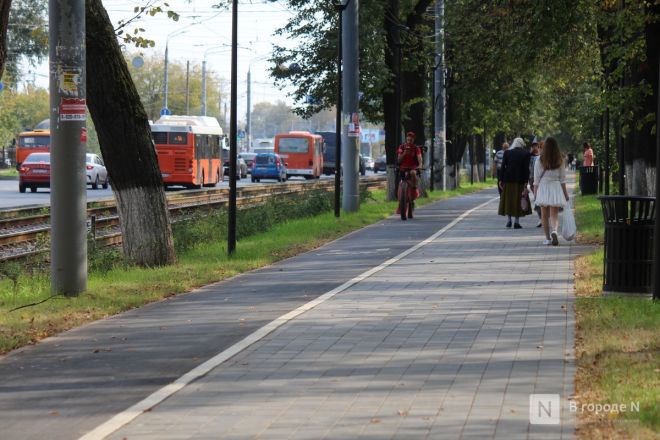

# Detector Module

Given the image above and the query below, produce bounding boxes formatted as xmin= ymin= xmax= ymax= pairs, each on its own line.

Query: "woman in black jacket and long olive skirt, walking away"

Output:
xmin=498 ymin=138 xmax=532 ymax=229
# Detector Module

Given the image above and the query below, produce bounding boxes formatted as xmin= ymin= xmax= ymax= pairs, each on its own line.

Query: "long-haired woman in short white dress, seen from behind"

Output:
xmin=534 ymin=137 xmax=570 ymax=246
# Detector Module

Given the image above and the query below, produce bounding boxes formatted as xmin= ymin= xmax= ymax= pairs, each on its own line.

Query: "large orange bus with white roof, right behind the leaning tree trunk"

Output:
xmin=151 ymin=116 xmax=225 ymax=188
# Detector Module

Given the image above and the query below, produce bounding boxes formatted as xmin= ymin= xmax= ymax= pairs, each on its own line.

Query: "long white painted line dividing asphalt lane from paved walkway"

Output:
xmin=79 ymin=197 xmax=499 ymax=440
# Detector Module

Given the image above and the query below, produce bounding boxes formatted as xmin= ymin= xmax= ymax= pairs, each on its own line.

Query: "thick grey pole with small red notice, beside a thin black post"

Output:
xmin=342 ymin=0 xmax=360 ymax=212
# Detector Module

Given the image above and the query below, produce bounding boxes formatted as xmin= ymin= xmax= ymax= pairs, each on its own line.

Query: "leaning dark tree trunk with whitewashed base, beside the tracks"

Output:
xmin=85 ymin=0 xmax=175 ymax=266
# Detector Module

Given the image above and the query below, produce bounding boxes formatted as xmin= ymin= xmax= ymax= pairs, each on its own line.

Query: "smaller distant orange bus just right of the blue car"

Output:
xmin=275 ymin=131 xmax=323 ymax=179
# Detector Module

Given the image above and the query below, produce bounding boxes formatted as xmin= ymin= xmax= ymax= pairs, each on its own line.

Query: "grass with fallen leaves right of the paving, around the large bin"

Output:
xmin=575 ymin=196 xmax=660 ymax=439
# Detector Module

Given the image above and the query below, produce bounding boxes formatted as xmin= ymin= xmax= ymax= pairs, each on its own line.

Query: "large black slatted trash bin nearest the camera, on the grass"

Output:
xmin=598 ymin=196 xmax=655 ymax=293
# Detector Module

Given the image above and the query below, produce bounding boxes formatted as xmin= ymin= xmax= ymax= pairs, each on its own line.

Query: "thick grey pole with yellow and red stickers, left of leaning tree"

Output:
xmin=49 ymin=0 xmax=87 ymax=296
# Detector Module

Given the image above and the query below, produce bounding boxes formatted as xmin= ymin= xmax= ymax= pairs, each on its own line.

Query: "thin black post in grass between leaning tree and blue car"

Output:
xmin=227 ymin=0 xmax=238 ymax=255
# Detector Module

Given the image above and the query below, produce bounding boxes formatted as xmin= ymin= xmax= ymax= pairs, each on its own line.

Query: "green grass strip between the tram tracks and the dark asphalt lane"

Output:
xmin=0 ymin=183 xmax=492 ymax=353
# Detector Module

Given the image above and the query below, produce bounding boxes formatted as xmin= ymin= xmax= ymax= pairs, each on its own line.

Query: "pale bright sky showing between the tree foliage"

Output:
xmin=30 ymin=0 xmax=293 ymax=119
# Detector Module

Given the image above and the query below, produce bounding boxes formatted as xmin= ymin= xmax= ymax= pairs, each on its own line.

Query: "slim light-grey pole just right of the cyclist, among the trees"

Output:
xmin=431 ymin=0 xmax=447 ymax=191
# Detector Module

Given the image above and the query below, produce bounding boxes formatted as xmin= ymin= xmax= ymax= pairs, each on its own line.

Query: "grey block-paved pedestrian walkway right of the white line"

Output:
xmin=96 ymin=193 xmax=575 ymax=440
